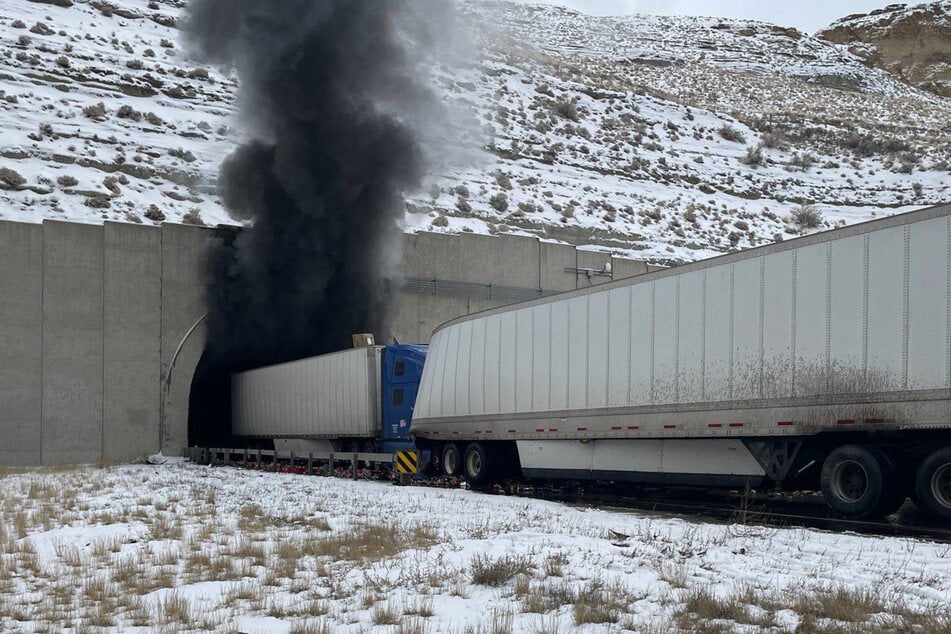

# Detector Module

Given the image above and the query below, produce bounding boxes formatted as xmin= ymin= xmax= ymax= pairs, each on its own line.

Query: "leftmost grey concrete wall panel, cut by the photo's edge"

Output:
xmin=0 ymin=221 xmax=43 ymax=465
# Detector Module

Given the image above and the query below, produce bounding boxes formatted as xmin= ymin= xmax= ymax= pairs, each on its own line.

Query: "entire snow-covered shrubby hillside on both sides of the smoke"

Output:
xmin=0 ymin=0 xmax=951 ymax=262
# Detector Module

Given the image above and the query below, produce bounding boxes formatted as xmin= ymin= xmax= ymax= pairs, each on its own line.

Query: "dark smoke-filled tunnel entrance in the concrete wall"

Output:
xmin=188 ymin=218 xmax=395 ymax=449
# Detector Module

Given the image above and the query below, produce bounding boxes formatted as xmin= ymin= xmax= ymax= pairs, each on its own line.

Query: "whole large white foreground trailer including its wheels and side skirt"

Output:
xmin=413 ymin=205 xmax=951 ymax=518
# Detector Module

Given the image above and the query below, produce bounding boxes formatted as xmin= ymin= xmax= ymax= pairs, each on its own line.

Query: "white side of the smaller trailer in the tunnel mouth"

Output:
xmin=231 ymin=346 xmax=383 ymax=438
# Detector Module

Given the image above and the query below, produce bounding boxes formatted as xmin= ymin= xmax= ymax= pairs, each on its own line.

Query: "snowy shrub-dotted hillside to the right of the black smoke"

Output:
xmin=429 ymin=1 xmax=951 ymax=261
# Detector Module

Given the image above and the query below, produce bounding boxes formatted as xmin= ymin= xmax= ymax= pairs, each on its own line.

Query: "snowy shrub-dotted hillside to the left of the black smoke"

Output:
xmin=0 ymin=0 xmax=235 ymax=223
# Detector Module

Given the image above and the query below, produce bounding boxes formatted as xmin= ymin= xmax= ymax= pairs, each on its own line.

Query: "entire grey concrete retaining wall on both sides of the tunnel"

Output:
xmin=0 ymin=221 xmax=647 ymax=466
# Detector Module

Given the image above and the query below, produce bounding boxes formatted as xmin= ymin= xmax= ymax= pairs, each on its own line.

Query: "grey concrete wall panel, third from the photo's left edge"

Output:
xmin=102 ymin=222 xmax=162 ymax=462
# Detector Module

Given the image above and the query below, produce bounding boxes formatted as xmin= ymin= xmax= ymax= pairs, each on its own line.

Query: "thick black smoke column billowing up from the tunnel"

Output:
xmin=185 ymin=0 xmax=447 ymax=442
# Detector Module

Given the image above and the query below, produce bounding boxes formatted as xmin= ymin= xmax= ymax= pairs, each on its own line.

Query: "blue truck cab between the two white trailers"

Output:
xmin=379 ymin=344 xmax=429 ymax=453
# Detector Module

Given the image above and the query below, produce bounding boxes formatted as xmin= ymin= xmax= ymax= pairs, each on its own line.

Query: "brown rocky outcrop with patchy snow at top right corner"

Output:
xmin=818 ymin=1 xmax=951 ymax=97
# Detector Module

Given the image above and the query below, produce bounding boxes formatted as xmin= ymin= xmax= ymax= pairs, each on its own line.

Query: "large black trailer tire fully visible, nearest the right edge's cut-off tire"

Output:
xmin=819 ymin=445 xmax=904 ymax=519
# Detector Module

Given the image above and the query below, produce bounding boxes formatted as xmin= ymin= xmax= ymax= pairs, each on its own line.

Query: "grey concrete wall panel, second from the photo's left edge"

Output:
xmin=41 ymin=222 xmax=103 ymax=464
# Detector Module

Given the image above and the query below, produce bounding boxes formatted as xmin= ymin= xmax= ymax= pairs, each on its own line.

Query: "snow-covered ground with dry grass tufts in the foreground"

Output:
xmin=0 ymin=463 xmax=951 ymax=633
